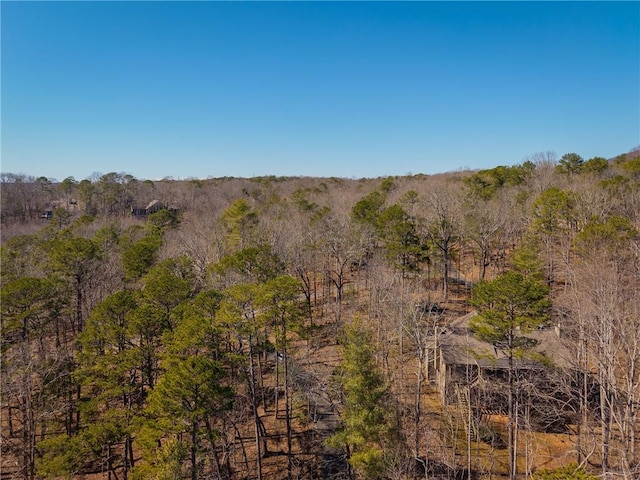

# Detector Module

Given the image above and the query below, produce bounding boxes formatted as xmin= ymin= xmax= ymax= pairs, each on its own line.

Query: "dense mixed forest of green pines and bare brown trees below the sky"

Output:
xmin=0 ymin=149 xmax=640 ymax=480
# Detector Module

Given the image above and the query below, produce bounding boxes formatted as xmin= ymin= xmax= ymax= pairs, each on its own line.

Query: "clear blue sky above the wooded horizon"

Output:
xmin=1 ymin=1 xmax=640 ymax=180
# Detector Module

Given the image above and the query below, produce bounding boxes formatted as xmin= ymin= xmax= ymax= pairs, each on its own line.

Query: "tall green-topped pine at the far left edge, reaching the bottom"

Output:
xmin=0 ymin=277 xmax=71 ymax=479
